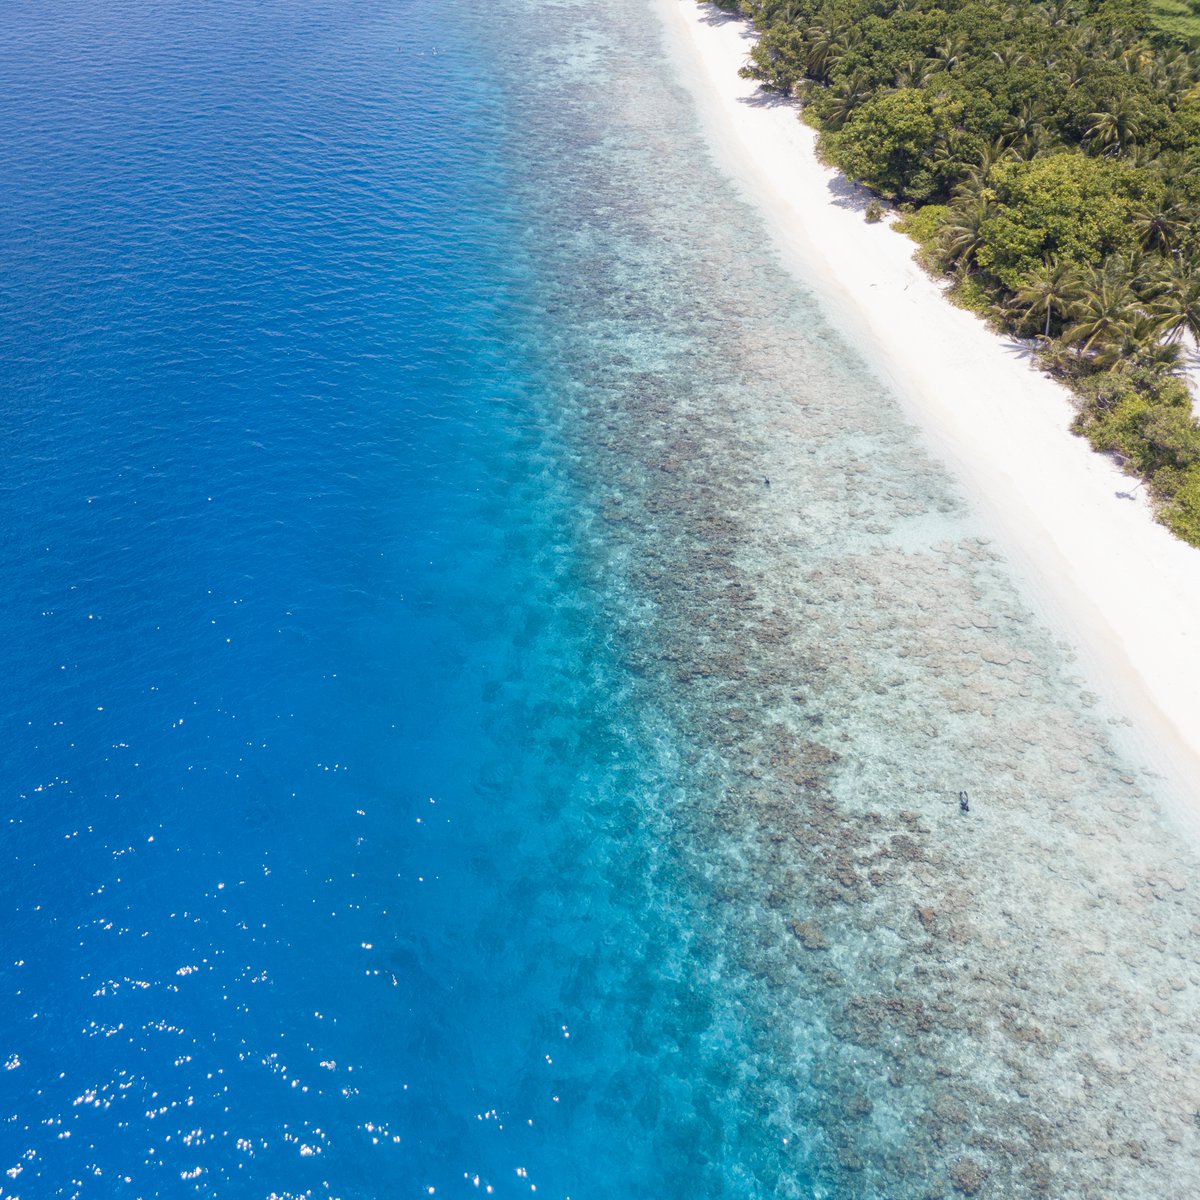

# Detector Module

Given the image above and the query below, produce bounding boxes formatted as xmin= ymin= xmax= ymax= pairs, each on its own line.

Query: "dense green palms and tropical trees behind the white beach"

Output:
xmin=721 ymin=0 xmax=1200 ymax=545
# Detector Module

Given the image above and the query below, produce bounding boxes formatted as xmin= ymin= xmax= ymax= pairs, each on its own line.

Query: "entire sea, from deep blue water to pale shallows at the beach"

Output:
xmin=0 ymin=0 xmax=1200 ymax=1200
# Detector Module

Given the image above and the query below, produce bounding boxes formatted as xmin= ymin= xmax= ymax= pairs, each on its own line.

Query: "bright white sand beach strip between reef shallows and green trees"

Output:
xmin=656 ymin=0 xmax=1200 ymax=818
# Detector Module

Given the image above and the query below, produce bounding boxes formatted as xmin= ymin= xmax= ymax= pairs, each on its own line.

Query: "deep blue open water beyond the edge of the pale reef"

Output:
xmin=0 ymin=0 xmax=729 ymax=1198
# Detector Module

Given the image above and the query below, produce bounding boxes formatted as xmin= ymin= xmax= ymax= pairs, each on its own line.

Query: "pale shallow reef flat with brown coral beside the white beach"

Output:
xmin=487 ymin=2 xmax=1200 ymax=1198
